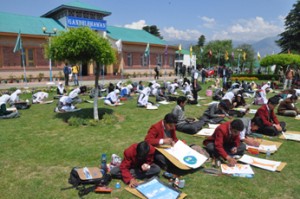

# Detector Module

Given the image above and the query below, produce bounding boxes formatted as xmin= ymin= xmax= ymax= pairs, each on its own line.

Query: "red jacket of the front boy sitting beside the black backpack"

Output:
xmin=120 ymin=143 xmax=155 ymax=184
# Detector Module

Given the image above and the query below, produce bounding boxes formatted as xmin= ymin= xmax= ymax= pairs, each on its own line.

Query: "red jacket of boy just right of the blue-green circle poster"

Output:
xmin=203 ymin=121 xmax=240 ymax=158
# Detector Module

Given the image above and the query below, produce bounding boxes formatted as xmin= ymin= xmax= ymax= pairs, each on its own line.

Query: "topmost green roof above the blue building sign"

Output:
xmin=42 ymin=1 xmax=111 ymax=17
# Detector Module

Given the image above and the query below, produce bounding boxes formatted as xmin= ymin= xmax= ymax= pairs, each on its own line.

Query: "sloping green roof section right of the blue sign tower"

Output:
xmin=107 ymin=26 xmax=167 ymax=45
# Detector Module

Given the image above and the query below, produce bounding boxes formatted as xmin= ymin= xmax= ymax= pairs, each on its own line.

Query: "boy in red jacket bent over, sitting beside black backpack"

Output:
xmin=110 ymin=141 xmax=160 ymax=188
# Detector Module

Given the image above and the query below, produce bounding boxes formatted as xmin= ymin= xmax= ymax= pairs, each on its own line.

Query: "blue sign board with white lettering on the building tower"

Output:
xmin=67 ymin=16 xmax=106 ymax=31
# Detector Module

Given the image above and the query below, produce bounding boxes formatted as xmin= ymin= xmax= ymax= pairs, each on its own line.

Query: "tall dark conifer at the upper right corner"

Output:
xmin=276 ymin=0 xmax=300 ymax=53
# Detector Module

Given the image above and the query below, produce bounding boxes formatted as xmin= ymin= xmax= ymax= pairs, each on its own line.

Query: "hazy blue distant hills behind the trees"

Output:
xmin=167 ymin=36 xmax=281 ymax=57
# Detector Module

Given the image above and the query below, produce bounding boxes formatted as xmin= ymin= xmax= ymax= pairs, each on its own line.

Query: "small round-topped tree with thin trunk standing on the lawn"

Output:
xmin=46 ymin=27 xmax=116 ymax=120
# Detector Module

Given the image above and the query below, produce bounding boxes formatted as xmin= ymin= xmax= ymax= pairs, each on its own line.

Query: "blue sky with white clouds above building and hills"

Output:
xmin=0 ymin=0 xmax=297 ymax=43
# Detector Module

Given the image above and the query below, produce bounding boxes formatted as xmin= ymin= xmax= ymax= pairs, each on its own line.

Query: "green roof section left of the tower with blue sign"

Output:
xmin=0 ymin=12 xmax=64 ymax=35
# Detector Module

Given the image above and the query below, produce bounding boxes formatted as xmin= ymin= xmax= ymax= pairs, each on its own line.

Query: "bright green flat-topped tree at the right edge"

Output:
xmin=260 ymin=54 xmax=300 ymax=73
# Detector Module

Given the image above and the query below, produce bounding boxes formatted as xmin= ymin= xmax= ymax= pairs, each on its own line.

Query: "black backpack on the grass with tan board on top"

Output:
xmin=62 ymin=167 xmax=111 ymax=196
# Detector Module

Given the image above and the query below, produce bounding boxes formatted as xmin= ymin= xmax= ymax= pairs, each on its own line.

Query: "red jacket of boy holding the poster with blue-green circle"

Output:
xmin=145 ymin=120 xmax=178 ymax=146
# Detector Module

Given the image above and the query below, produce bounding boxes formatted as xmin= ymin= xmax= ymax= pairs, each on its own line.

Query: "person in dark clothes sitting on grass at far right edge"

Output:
xmin=277 ymin=95 xmax=300 ymax=117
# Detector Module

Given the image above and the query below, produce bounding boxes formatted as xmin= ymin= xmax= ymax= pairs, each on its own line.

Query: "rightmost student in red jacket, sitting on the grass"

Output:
xmin=254 ymin=96 xmax=286 ymax=136
